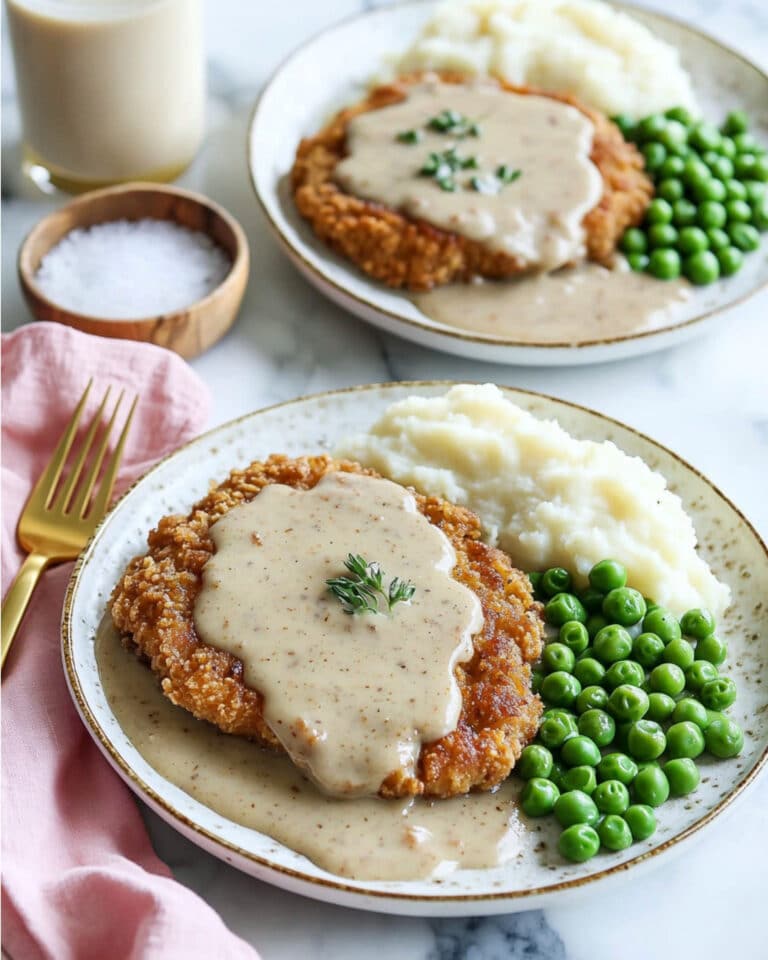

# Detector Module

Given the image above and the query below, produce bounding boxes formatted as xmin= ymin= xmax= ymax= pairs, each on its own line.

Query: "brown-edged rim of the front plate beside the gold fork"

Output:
xmin=61 ymin=379 xmax=768 ymax=905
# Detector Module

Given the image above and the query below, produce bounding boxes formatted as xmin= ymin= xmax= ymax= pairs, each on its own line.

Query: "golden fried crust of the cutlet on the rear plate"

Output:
xmin=291 ymin=72 xmax=653 ymax=290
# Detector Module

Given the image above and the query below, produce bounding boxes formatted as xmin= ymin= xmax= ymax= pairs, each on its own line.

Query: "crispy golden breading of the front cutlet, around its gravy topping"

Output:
xmin=111 ymin=455 xmax=542 ymax=797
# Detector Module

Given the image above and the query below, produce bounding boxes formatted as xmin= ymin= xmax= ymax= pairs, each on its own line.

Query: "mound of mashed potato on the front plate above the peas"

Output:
xmin=336 ymin=384 xmax=730 ymax=616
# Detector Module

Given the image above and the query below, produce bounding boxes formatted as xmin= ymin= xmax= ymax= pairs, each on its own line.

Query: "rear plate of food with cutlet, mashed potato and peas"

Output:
xmin=249 ymin=2 xmax=768 ymax=365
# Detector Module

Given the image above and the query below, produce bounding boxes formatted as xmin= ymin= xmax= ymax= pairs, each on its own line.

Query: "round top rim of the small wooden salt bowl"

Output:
xmin=16 ymin=180 xmax=250 ymax=330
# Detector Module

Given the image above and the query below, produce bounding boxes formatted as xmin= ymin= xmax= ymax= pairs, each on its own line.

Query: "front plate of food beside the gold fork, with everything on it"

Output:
xmin=63 ymin=383 xmax=768 ymax=915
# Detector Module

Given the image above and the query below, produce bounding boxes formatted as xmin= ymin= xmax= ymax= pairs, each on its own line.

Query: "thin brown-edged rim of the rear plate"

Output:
xmin=245 ymin=0 xmax=768 ymax=352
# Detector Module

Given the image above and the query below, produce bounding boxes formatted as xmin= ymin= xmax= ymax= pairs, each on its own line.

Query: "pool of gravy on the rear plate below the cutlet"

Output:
xmin=413 ymin=263 xmax=691 ymax=344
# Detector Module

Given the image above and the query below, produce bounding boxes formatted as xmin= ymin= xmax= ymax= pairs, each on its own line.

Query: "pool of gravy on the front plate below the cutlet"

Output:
xmin=96 ymin=617 xmax=528 ymax=880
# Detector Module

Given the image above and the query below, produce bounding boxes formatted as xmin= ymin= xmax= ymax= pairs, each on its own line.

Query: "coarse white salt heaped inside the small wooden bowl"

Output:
xmin=35 ymin=218 xmax=232 ymax=320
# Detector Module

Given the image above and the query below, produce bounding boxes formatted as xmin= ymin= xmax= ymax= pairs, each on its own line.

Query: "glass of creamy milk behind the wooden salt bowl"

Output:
xmin=6 ymin=0 xmax=205 ymax=192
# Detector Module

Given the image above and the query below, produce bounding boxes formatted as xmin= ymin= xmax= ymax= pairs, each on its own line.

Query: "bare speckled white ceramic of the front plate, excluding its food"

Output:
xmin=62 ymin=383 xmax=768 ymax=915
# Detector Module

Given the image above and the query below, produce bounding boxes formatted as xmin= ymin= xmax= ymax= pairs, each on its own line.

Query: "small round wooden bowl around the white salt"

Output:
xmin=18 ymin=183 xmax=249 ymax=358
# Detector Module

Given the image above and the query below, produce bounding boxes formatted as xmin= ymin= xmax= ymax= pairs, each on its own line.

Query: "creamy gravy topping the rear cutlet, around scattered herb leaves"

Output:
xmin=334 ymin=82 xmax=603 ymax=270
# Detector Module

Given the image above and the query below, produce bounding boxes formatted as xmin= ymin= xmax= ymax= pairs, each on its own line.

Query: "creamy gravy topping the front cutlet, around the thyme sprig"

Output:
xmin=195 ymin=472 xmax=483 ymax=796
